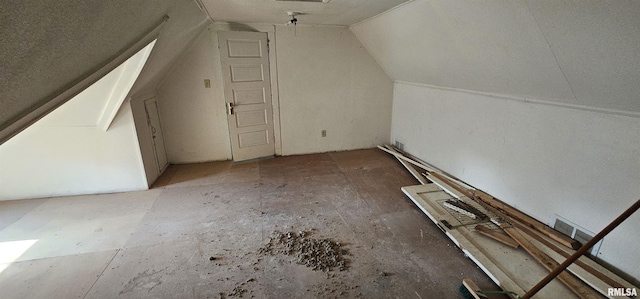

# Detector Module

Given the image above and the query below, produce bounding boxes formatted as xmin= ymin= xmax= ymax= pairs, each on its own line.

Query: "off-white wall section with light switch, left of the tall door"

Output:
xmin=157 ymin=30 xmax=231 ymax=164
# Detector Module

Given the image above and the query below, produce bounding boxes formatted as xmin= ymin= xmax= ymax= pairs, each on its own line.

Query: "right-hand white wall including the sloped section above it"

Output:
xmin=351 ymin=0 xmax=640 ymax=278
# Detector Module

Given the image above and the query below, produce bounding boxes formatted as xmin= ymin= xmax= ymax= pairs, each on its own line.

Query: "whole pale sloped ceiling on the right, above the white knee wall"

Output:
xmin=352 ymin=0 xmax=640 ymax=113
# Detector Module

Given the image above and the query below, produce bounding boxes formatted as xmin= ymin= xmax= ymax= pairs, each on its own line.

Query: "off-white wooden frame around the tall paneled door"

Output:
xmin=210 ymin=22 xmax=282 ymax=156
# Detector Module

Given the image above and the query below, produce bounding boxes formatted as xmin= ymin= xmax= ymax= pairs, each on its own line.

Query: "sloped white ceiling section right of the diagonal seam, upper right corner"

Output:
xmin=526 ymin=0 xmax=640 ymax=112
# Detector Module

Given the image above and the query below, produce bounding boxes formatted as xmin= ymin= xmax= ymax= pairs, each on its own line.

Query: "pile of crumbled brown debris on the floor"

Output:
xmin=258 ymin=231 xmax=349 ymax=272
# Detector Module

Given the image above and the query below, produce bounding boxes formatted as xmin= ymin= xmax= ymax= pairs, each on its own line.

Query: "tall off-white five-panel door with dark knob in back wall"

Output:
xmin=218 ymin=31 xmax=275 ymax=161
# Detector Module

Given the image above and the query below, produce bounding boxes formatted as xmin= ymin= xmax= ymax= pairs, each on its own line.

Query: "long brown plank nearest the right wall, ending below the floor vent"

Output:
xmin=471 ymin=190 xmax=580 ymax=249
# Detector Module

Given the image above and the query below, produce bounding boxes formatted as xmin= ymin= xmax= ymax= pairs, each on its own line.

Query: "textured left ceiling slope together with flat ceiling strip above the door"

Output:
xmin=0 ymin=0 xmax=407 ymax=144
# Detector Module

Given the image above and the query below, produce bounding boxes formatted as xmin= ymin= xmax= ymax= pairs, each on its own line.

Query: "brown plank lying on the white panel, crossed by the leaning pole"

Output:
xmin=501 ymin=225 xmax=602 ymax=299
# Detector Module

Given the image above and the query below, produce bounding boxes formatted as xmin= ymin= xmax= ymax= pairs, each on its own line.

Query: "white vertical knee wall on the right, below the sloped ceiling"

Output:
xmin=391 ymin=83 xmax=640 ymax=277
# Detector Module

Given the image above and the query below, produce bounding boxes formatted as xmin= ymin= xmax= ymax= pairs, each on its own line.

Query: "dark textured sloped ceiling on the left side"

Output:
xmin=0 ymin=0 xmax=206 ymax=143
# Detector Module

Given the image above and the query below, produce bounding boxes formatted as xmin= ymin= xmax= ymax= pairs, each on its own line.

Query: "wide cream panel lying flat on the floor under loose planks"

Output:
xmin=402 ymin=184 xmax=577 ymax=298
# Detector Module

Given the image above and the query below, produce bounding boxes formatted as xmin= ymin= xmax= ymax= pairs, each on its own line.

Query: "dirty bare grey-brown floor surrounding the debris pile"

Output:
xmin=0 ymin=149 xmax=497 ymax=298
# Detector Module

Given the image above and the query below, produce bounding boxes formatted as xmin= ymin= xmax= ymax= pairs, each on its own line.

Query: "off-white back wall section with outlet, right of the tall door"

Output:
xmin=276 ymin=26 xmax=393 ymax=155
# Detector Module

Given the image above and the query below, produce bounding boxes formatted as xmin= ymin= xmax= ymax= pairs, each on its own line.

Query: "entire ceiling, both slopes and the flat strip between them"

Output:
xmin=0 ymin=0 xmax=640 ymax=144
